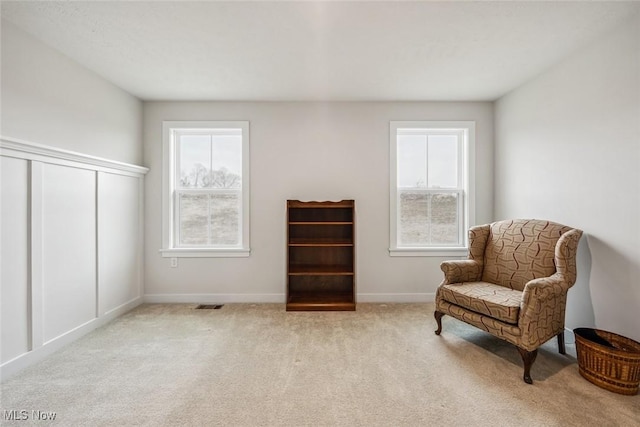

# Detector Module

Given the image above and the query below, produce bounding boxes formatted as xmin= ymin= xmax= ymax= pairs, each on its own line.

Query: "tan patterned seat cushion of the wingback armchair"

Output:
xmin=440 ymin=282 xmax=522 ymax=325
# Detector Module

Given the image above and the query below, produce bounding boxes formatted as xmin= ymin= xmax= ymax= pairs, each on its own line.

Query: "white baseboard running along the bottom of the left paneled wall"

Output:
xmin=0 ymin=297 xmax=142 ymax=382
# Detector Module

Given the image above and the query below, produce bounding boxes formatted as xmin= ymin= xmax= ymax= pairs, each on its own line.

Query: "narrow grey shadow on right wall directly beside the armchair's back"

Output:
xmin=565 ymin=237 xmax=596 ymax=334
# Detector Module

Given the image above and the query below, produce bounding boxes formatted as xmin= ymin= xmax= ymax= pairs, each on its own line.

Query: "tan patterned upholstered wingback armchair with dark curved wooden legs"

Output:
xmin=435 ymin=220 xmax=582 ymax=384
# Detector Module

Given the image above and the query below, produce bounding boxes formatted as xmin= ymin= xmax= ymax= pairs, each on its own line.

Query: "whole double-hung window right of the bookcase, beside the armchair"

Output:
xmin=389 ymin=122 xmax=475 ymax=256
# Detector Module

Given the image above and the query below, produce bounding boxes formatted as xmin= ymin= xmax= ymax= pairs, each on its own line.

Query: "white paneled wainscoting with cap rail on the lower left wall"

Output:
xmin=0 ymin=137 xmax=148 ymax=380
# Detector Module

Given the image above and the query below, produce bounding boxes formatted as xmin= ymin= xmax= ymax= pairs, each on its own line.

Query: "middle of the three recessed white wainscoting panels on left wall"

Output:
xmin=42 ymin=164 xmax=97 ymax=343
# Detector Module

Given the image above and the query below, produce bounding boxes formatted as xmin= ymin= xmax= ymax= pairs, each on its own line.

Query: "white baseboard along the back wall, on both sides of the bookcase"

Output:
xmin=144 ymin=293 xmax=435 ymax=304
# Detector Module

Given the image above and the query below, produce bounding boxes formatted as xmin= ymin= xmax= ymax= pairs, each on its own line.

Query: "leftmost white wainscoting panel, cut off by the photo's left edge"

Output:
xmin=0 ymin=157 xmax=31 ymax=363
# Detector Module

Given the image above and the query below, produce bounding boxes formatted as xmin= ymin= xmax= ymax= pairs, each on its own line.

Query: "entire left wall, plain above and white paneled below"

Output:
xmin=0 ymin=21 xmax=146 ymax=379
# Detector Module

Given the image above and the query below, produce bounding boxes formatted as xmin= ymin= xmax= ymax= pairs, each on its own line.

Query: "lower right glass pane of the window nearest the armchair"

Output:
xmin=430 ymin=193 xmax=458 ymax=245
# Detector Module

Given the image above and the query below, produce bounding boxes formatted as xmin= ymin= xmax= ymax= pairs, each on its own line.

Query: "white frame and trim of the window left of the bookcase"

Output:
xmin=160 ymin=121 xmax=251 ymax=258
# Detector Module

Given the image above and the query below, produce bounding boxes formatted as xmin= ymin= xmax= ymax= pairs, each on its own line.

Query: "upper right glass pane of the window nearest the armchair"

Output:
xmin=427 ymin=135 xmax=458 ymax=188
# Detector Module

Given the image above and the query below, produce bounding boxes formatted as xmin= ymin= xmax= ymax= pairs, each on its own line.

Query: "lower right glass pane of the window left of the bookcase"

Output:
xmin=210 ymin=194 xmax=240 ymax=245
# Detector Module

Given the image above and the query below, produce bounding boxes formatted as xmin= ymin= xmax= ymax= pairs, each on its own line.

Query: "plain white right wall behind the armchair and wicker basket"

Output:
xmin=495 ymin=16 xmax=640 ymax=340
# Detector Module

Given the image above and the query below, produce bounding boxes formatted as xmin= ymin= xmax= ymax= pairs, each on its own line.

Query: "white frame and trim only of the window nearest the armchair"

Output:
xmin=389 ymin=121 xmax=475 ymax=257
